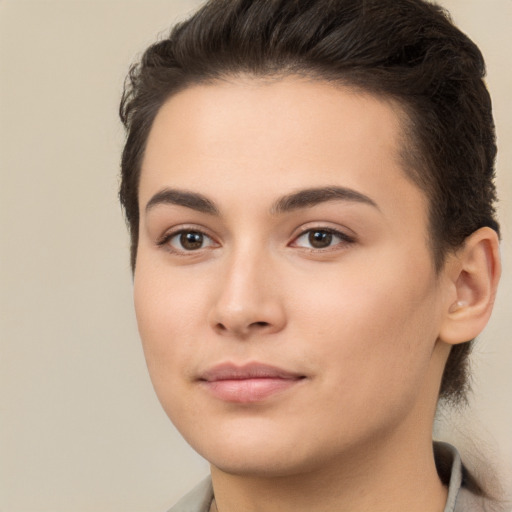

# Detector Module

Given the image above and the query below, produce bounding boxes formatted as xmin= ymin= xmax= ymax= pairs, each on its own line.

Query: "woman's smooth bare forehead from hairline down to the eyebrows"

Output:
xmin=140 ymin=78 xmax=425 ymax=228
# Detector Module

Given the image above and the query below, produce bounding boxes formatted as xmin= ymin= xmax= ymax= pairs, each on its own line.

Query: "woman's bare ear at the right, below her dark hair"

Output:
xmin=439 ymin=227 xmax=501 ymax=345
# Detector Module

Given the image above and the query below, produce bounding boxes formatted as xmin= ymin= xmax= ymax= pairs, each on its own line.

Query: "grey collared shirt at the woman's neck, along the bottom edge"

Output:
xmin=168 ymin=442 xmax=486 ymax=512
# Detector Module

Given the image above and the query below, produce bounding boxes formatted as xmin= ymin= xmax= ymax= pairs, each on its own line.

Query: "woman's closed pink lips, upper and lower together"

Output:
xmin=200 ymin=363 xmax=304 ymax=403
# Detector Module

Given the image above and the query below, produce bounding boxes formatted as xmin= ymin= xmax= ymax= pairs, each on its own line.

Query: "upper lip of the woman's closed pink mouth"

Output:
xmin=199 ymin=363 xmax=304 ymax=382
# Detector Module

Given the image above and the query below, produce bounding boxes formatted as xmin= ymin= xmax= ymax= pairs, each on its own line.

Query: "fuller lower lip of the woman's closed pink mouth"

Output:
xmin=203 ymin=377 xmax=302 ymax=403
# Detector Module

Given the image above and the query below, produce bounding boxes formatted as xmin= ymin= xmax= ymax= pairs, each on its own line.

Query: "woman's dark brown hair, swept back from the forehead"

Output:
xmin=120 ymin=0 xmax=499 ymax=403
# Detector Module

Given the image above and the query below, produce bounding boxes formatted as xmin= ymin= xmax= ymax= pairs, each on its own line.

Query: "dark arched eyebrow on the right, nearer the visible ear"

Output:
xmin=271 ymin=187 xmax=380 ymax=214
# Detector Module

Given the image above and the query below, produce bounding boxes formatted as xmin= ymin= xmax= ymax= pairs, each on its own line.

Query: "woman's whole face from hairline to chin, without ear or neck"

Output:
xmin=135 ymin=78 xmax=450 ymax=475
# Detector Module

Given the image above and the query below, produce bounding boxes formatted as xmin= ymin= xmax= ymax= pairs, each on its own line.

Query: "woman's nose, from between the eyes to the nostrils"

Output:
xmin=209 ymin=251 xmax=286 ymax=339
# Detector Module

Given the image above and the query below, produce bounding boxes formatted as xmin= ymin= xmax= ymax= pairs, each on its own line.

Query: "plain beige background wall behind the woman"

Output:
xmin=0 ymin=0 xmax=512 ymax=512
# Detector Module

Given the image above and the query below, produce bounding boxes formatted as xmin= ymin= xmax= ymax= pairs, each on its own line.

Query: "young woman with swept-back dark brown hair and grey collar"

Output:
xmin=120 ymin=0 xmax=500 ymax=512
